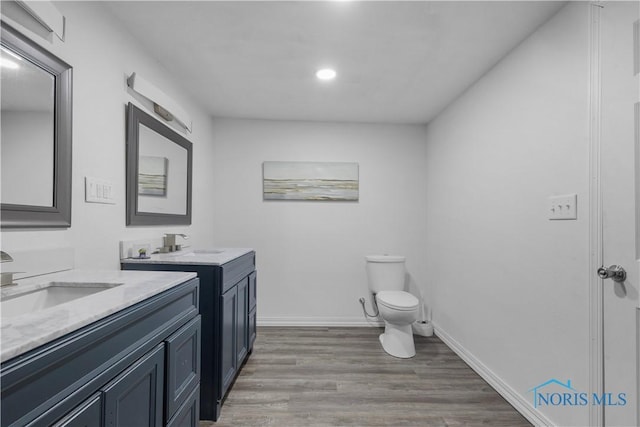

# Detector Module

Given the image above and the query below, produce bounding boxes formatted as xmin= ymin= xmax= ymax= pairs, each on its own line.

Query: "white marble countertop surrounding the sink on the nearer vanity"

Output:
xmin=0 ymin=270 xmax=197 ymax=362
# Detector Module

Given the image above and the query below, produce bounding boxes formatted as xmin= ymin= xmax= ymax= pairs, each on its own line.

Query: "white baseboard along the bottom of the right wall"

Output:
xmin=433 ymin=324 xmax=554 ymax=426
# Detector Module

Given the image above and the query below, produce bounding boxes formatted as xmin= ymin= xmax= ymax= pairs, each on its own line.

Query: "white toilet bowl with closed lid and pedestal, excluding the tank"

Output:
xmin=376 ymin=291 xmax=419 ymax=359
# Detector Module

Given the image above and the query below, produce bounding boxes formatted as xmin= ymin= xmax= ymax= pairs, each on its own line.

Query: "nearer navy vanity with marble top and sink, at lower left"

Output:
xmin=0 ymin=270 xmax=201 ymax=427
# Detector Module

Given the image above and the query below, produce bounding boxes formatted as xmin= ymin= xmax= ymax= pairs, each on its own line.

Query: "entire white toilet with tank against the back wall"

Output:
xmin=365 ymin=255 xmax=419 ymax=359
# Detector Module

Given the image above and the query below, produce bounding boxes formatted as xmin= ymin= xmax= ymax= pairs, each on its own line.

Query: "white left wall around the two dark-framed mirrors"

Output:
xmin=1 ymin=2 xmax=214 ymax=269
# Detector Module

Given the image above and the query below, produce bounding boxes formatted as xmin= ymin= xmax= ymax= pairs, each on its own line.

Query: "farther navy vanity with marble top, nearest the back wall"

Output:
xmin=121 ymin=248 xmax=257 ymax=420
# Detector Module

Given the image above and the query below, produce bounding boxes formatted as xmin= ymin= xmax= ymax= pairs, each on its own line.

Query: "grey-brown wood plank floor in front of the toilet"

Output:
xmin=200 ymin=327 xmax=531 ymax=427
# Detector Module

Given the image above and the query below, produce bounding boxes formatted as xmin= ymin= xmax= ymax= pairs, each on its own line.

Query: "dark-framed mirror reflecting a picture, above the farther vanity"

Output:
xmin=127 ymin=103 xmax=193 ymax=225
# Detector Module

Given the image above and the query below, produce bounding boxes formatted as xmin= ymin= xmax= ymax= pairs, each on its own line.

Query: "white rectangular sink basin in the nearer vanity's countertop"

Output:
xmin=0 ymin=282 xmax=122 ymax=319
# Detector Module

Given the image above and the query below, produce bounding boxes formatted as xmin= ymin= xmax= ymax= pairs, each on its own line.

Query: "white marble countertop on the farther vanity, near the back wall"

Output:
xmin=120 ymin=248 xmax=253 ymax=265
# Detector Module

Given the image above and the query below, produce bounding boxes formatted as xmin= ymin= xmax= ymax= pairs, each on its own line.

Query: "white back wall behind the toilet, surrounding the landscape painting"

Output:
xmin=210 ymin=119 xmax=426 ymax=325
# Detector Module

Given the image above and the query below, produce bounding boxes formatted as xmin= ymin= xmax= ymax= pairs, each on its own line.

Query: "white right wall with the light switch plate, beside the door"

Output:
xmin=425 ymin=3 xmax=590 ymax=425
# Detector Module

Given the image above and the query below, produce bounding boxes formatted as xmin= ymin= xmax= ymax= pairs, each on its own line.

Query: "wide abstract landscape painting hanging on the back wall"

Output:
xmin=262 ymin=162 xmax=359 ymax=201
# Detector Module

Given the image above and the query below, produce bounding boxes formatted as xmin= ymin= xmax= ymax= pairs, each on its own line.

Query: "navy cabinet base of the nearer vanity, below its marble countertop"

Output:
xmin=0 ymin=278 xmax=201 ymax=427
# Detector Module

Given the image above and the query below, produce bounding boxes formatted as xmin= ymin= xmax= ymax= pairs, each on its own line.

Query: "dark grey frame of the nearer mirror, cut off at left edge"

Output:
xmin=0 ymin=21 xmax=73 ymax=228
